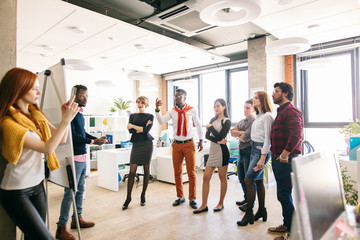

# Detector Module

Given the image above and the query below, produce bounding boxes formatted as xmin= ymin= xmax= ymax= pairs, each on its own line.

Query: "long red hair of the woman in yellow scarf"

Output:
xmin=0 ymin=68 xmax=38 ymax=124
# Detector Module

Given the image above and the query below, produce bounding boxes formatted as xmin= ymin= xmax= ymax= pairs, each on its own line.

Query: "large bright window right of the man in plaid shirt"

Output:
xmin=301 ymin=51 xmax=358 ymax=127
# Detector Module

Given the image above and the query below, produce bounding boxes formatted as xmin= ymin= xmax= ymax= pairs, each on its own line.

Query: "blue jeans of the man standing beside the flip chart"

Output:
xmin=58 ymin=161 xmax=86 ymax=225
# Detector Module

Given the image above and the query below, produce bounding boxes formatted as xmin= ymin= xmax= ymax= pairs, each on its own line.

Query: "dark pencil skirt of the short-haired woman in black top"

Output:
xmin=130 ymin=141 xmax=153 ymax=165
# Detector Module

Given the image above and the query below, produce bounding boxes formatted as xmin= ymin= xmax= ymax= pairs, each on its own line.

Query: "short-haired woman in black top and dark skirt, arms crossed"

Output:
xmin=122 ymin=96 xmax=154 ymax=210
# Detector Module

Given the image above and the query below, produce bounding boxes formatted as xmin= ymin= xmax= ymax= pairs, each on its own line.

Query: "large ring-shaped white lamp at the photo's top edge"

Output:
xmin=200 ymin=0 xmax=261 ymax=26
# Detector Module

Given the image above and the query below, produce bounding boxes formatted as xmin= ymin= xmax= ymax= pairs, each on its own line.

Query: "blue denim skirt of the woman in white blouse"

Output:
xmin=245 ymin=142 xmax=270 ymax=180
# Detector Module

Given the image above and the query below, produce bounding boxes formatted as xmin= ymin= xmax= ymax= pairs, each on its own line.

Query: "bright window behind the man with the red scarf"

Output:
xmin=168 ymin=67 xmax=249 ymax=126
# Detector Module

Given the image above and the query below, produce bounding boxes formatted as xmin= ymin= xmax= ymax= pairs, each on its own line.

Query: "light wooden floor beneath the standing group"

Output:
xmin=18 ymin=171 xmax=282 ymax=240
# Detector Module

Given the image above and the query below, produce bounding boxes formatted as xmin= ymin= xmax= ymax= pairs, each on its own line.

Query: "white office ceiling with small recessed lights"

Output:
xmin=17 ymin=0 xmax=360 ymax=74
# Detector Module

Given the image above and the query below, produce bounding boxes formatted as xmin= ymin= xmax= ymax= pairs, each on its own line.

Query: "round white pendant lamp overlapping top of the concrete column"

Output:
xmin=265 ymin=37 xmax=311 ymax=56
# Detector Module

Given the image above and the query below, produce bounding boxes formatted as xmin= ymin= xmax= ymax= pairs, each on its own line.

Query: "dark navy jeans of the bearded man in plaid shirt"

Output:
xmin=271 ymin=154 xmax=294 ymax=232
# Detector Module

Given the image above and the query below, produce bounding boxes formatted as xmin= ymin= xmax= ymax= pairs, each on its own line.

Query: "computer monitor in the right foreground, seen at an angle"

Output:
xmin=292 ymin=152 xmax=345 ymax=240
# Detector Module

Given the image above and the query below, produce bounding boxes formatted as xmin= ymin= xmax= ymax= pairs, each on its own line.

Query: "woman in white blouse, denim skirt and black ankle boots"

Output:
xmin=237 ymin=91 xmax=274 ymax=226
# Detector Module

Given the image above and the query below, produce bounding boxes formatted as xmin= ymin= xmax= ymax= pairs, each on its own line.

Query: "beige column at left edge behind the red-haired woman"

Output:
xmin=0 ymin=0 xmax=17 ymax=240
